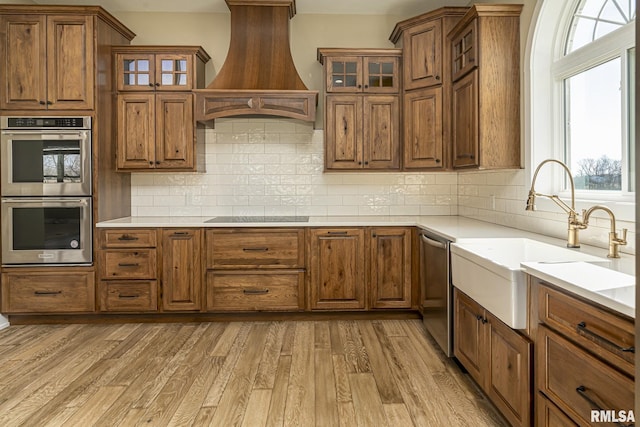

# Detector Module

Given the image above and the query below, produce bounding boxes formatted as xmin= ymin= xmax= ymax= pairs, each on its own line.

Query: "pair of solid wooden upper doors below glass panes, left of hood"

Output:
xmin=117 ymin=93 xmax=196 ymax=170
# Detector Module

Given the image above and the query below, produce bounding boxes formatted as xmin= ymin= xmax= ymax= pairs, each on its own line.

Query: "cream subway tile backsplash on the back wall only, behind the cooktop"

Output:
xmin=131 ymin=118 xmax=458 ymax=216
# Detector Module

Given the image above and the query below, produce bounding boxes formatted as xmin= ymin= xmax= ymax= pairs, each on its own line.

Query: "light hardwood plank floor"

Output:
xmin=0 ymin=319 xmax=504 ymax=427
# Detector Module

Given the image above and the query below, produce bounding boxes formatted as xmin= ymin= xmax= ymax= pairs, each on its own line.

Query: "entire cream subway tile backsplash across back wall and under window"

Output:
xmin=131 ymin=118 xmax=635 ymax=253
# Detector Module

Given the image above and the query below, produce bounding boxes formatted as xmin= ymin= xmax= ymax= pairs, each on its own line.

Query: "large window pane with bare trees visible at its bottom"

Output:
xmin=565 ymin=58 xmax=622 ymax=191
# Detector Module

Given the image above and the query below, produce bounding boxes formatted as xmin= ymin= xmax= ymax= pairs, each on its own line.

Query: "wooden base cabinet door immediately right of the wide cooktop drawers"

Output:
xmin=309 ymin=228 xmax=366 ymax=310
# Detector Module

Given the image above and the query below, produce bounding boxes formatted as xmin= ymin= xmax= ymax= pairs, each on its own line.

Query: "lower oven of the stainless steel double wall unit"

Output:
xmin=1 ymin=197 xmax=92 ymax=266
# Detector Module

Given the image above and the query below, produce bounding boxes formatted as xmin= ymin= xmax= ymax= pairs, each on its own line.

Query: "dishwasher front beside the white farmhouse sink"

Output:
xmin=420 ymin=231 xmax=453 ymax=357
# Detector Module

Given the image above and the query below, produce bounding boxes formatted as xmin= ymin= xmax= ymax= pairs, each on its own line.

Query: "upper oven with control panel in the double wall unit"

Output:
xmin=0 ymin=116 xmax=91 ymax=196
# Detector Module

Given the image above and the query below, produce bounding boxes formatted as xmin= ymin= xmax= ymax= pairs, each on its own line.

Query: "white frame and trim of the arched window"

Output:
xmin=525 ymin=0 xmax=637 ymax=221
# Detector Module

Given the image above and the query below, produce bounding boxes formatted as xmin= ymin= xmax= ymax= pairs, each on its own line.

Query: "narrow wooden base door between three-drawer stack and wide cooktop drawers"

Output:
xmin=162 ymin=228 xmax=203 ymax=311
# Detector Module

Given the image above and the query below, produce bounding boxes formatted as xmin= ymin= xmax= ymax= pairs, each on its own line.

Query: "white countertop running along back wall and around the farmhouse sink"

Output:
xmin=97 ymin=216 xmax=635 ymax=317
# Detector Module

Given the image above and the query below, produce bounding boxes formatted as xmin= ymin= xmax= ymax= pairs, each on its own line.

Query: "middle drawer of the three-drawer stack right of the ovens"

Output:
xmin=100 ymin=249 xmax=157 ymax=280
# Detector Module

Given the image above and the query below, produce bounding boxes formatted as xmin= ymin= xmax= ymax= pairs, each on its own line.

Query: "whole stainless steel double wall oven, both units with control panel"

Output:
xmin=0 ymin=117 xmax=92 ymax=266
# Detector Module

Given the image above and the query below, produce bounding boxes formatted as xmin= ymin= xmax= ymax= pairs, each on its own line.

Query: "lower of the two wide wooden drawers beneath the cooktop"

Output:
xmin=207 ymin=270 xmax=304 ymax=311
